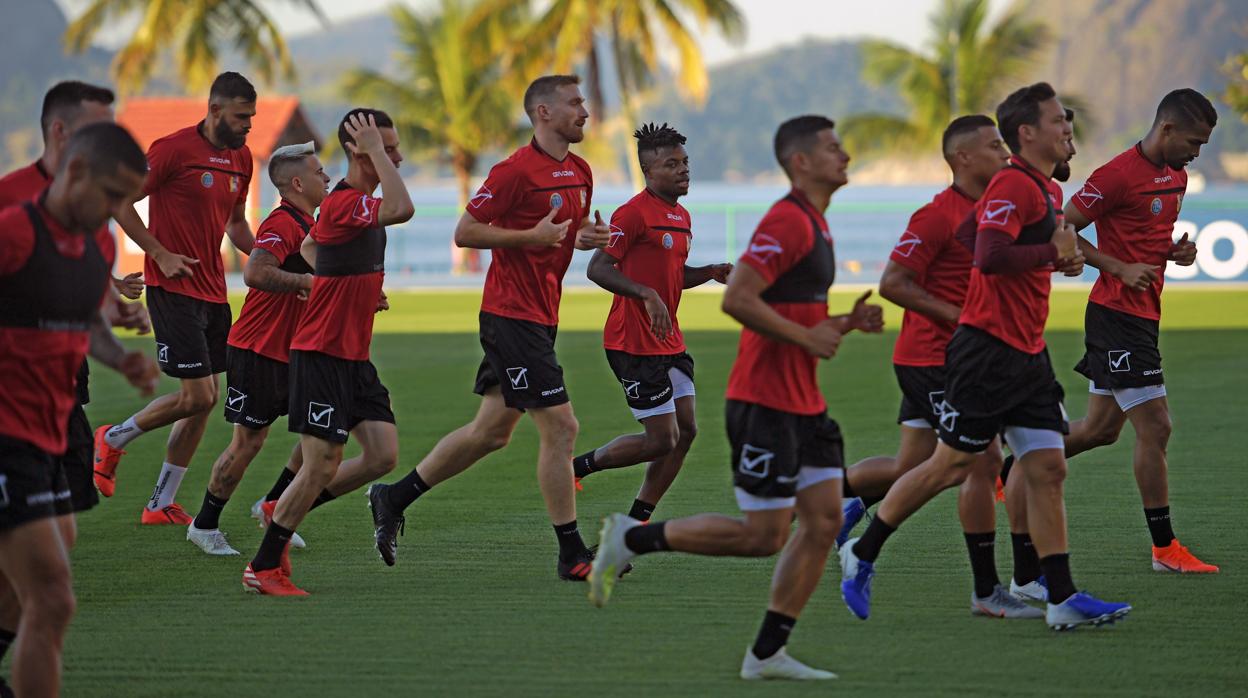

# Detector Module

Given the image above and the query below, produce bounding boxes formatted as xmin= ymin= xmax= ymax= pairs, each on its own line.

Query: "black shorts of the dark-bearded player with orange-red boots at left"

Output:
xmin=146 ymin=286 xmax=232 ymax=378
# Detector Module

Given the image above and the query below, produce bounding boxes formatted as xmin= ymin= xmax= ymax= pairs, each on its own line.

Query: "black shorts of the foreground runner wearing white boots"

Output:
xmin=725 ymin=400 xmax=845 ymax=508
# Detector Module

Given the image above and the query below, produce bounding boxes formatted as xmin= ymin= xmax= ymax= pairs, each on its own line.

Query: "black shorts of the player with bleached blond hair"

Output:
xmin=225 ymin=347 xmax=291 ymax=430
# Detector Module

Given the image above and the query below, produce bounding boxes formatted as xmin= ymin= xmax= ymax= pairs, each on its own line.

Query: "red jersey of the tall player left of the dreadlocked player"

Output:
xmin=467 ymin=141 xmax=594 ymax=326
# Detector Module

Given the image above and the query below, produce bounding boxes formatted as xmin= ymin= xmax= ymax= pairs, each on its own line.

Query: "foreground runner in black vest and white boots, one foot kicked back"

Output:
xmin=589 ymin=116 xmax=884 ymax=679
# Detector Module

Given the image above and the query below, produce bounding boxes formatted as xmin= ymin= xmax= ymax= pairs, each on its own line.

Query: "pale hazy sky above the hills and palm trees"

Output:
xmin=56 ymin=0 xmax=973 ymax=64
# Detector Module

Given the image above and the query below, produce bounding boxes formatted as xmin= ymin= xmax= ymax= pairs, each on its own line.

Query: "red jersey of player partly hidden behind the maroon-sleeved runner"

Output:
xmin=889 ymin=186 xmax=975 ymax=366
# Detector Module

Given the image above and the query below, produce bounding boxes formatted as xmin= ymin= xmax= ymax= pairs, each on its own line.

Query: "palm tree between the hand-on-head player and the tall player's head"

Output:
xmin=344 ymin=0 xmax=527 ymax=272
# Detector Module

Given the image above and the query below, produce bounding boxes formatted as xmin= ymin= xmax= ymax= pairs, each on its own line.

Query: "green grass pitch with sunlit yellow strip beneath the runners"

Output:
xmin=65 ymin=290 xmax=1248 ymax=697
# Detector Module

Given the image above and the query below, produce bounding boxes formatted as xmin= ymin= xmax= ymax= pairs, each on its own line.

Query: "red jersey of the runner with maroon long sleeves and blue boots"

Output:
xmin=960 ymin=155 xmax=1062 ymax=353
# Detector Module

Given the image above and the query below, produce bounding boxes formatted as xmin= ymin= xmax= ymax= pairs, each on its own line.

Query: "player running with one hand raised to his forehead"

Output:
xmin=242 ymin=109 xmax=413 ymax=596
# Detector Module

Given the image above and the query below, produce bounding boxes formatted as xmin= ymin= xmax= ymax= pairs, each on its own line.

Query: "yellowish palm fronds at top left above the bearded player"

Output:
xmin=65 ymin=0 xmax=327 ymax=94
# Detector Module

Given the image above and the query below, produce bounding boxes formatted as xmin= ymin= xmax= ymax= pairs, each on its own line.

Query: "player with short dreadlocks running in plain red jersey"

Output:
xmin=572 ymin=124 xmax=733 ymax=521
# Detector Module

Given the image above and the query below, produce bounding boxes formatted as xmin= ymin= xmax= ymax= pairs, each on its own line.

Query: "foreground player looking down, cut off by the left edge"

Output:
xmin=0 ymin=124 xmax=157 ymax=698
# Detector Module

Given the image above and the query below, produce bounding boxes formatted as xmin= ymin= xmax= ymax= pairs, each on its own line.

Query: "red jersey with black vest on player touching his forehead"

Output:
xmin=291 ymin=181 xmax=386 ymax=361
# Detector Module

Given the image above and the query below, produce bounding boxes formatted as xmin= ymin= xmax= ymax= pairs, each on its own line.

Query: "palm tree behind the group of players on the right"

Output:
xmin=841 ymin=0 xmax=1053 ymax=155
